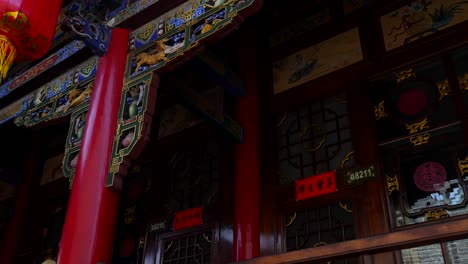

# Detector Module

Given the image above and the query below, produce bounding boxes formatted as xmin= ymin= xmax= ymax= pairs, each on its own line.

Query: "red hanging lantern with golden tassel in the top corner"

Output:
xmin=0 ymin=0 xmax=62 ymax=81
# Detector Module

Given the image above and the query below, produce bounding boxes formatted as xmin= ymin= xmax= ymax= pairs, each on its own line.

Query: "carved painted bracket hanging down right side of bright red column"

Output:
xmin=106 ymin=74 xmax=159 ymax=189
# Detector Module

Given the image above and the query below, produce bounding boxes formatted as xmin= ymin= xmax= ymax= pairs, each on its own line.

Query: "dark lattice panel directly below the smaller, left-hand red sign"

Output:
xmin=162 ymin=231 xmax=212 ymax=264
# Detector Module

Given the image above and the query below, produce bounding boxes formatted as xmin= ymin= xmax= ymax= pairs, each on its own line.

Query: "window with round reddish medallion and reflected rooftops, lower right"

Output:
xmin=383 ymin=125 xmax=468 ymax=227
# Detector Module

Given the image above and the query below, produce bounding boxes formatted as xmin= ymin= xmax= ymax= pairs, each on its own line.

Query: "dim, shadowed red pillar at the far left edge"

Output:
xmin=0 ymin=132 xmax=43 ymax=264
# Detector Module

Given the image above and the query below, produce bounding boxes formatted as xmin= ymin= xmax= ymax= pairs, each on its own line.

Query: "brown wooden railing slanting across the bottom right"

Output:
xmin=237 ymin=219 xmax=468 ymax=264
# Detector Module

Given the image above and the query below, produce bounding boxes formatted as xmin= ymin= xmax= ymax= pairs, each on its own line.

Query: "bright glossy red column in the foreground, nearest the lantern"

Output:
xmin=58 ymin=28 xmax=129 ymax=264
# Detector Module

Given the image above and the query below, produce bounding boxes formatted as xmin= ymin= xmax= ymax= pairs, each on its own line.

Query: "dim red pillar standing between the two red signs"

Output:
xmin=233 ymin=25 xmax=260 ymax=261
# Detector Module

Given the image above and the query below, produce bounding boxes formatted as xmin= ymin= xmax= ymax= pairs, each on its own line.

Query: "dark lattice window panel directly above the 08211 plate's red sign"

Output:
xmin=277 ymin=96 xmax=352 ymax=184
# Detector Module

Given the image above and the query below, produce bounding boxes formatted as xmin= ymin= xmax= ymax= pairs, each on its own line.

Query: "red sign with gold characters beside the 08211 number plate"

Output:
xmin=296 ymin=171 xmax=336 ymax=201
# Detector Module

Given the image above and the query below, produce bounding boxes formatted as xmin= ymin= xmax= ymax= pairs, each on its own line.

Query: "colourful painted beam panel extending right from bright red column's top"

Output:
xmin=127 ymin=0 xmax=254 ymax=79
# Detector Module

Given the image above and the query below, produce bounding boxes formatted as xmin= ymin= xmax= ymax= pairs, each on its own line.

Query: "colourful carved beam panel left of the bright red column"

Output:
xmin=15 ymin=58 xmax=97 ymax=126
